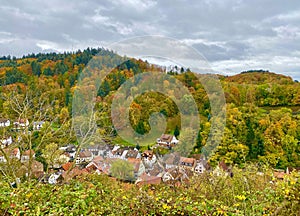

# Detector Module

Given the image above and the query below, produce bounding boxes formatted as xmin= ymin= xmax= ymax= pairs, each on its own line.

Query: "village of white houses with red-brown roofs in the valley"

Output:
xmin=0 ymin=119 xmax=296 ymax=185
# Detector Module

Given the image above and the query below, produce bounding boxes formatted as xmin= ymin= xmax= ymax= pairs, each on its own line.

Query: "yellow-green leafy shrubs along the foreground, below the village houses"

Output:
xmin=0 ymin=169 xmax=300 ymax=215
